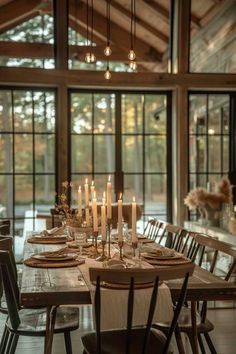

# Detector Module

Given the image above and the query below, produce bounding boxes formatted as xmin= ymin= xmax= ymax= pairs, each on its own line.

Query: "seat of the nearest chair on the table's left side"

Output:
xmin=6 ymin=307 xmax=79 ymax=336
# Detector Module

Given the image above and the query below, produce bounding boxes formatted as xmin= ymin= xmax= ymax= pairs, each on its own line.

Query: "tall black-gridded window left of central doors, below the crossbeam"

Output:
xmin=0 ymin=88 xmax=55 ymax=235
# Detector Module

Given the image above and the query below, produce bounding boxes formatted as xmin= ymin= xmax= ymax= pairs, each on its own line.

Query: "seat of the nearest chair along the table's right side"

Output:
xmin=155 ymin=307 xmax=214 ymax=333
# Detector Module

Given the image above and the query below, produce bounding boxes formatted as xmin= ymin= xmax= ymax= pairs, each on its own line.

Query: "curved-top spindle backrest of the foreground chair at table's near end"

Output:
xmin=89 ymin=263 xmax=194 ymax=354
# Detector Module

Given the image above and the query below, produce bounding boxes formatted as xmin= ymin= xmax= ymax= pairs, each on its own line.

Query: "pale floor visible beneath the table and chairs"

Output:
xmin=0 ymin=306 xmax=236 ymax=354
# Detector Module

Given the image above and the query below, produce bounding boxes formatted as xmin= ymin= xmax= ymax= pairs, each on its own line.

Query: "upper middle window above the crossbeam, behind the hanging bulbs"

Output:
xmin=68 ymin=0 xmax=170 ymax=72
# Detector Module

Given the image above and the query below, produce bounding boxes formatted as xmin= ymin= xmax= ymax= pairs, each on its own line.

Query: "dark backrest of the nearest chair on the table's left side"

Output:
xmin=0 ymin=240 xmax=20 ymax=329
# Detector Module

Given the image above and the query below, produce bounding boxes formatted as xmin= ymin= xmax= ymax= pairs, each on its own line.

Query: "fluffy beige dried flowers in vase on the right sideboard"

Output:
xmin=184 ymin=178 xmax=232 ymax=219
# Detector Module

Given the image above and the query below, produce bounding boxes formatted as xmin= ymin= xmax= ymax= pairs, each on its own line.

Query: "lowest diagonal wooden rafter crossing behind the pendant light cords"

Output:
xmin=71 ymin=1 xmax=162 ymax=62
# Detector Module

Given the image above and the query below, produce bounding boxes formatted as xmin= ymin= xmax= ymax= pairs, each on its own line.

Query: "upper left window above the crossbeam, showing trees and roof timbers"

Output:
xmin=0 ymin=0 xmax=54 ymax=69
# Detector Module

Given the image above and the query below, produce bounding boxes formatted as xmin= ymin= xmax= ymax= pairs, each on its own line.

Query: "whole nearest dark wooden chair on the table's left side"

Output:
xmin=0 ymin=240 xmax=79 ymax=354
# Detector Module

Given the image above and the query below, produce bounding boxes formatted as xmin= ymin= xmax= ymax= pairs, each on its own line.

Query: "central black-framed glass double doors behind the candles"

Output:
xmin=70 ymin=91 xmax=170 ymax=223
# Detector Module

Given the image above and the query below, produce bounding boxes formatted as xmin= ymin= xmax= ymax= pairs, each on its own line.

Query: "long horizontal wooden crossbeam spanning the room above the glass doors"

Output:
xmin=0 ymin=67 xmax=236 ymax=91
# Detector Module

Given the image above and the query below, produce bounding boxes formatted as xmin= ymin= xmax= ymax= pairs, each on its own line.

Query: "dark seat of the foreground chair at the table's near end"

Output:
xmin=81 ymin=327 xmax=174 ymax=354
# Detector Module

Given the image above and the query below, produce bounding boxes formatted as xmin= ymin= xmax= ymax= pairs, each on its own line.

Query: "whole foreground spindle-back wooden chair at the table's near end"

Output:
xmin=82 ymin=263 xmax=194 ymax=354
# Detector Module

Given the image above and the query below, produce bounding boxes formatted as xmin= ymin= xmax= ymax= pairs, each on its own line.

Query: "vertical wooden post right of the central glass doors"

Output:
xmin=172 ymin=0 xmax=191 ymax=225
